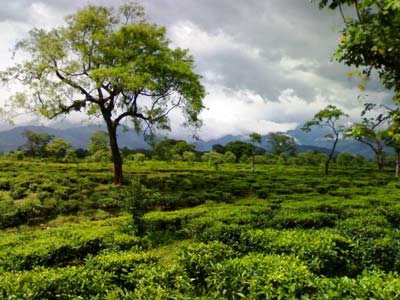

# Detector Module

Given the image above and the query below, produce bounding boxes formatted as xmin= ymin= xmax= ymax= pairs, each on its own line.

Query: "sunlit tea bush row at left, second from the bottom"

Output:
xmin=0 ymin=218 xmax=149 ymax=271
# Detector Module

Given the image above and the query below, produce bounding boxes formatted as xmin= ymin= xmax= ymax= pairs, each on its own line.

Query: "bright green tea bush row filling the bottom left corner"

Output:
xmin=0 ymin=252 xmax=158 ymax=299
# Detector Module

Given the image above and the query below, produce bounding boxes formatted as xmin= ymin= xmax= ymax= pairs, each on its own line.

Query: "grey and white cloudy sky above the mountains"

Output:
xmin=0 ymin=0 xmax=390 ymax=139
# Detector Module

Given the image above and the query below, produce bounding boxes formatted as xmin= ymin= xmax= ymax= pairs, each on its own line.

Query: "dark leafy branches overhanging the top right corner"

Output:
xmin=312 ymin=0 xmax=400 ymax=98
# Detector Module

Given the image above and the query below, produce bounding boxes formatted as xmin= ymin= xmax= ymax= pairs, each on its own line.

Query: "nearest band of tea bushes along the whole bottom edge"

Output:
xmin=0 ymin=242 xmax=400 ymax=300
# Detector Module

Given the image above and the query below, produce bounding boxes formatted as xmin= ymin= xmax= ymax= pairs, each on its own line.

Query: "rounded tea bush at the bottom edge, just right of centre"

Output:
xmin=206 ymin=254 xmax=316 ymax=299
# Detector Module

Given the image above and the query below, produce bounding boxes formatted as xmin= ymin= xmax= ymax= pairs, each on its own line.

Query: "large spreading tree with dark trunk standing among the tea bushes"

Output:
xmin=1 ymin=3 xmax=205 ymax=184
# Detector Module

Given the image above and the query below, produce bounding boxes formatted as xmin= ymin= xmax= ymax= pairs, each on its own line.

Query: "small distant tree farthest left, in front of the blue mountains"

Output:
xmin=21 ymin=130 xmax=54 ymax=157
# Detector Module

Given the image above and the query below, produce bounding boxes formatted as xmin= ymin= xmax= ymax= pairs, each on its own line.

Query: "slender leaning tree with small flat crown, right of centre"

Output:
xmin=302 ymin=105 xmax=347 ymax=175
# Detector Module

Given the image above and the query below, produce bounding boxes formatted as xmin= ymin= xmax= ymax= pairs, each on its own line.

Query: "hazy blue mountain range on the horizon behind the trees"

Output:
xmin=0 ymin=125 xmax=373 ymax=158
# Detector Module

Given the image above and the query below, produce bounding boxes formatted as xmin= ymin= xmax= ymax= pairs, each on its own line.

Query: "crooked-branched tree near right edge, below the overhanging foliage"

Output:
xmin=344 ymin=103 xmax=390 ymax=171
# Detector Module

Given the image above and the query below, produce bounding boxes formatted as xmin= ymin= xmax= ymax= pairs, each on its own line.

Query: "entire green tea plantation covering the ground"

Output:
xmin=0 ymin=159 xmax=400 ymax=300
